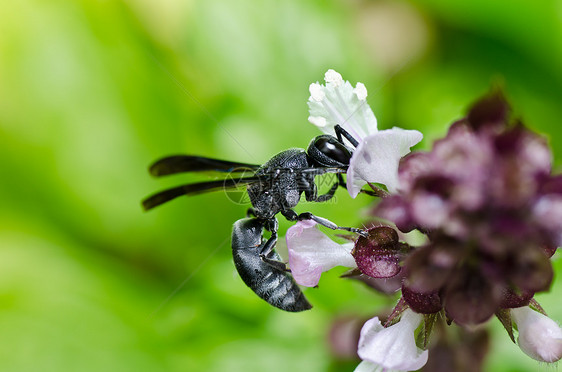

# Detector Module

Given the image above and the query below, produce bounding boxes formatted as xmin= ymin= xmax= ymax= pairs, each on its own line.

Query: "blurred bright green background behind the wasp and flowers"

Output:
xmin=0 ymin=0 xmax=562 ymax=372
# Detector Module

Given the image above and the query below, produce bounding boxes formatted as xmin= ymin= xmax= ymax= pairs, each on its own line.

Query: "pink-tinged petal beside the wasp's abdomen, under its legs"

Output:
xmin=286 ymin=221 xmax=356 ymax=287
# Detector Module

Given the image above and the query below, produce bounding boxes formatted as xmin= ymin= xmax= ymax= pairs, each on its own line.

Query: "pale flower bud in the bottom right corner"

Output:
xmin=511 ymin=306 xmax=562 ymax=363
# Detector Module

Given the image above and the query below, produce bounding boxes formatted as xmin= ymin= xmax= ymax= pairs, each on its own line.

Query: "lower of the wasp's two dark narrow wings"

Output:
xmin=142 ymin=177 xmax=263 ymax=211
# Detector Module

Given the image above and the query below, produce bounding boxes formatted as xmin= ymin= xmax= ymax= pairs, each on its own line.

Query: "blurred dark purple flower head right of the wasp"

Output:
xmin=375 ymin=92 xmax=562 ymax=325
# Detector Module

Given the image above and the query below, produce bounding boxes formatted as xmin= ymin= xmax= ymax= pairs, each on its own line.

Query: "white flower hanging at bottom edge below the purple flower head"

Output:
xmin=355 ymin=309 xmax=428 ymax=372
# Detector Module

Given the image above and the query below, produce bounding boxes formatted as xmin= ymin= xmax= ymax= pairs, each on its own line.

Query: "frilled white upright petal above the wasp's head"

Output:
xmin=308 ymin=70 xmax=377 ymax=142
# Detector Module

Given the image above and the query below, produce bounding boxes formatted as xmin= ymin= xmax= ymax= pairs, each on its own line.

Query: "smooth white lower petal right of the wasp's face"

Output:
xmin=347 ymin=128 xmax=423 ymax=198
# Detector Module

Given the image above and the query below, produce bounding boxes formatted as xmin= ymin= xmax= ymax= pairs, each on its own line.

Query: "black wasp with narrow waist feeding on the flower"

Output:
xmin=142 ymin=125 xmax=364 ymax=312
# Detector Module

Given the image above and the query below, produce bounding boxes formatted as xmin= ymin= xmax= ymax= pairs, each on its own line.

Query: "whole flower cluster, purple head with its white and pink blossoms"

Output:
xmin=286 ymin=70 xmax=562 ymax=372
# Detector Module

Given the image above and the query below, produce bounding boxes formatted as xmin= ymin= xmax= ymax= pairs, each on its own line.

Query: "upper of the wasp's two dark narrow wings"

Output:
xmin=149 ymin=155 xmax=260 ymax=177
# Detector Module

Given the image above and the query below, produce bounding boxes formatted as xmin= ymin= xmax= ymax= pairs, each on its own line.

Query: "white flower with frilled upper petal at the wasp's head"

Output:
xmin=308 ymin=70 xmax=423 ymax=198
